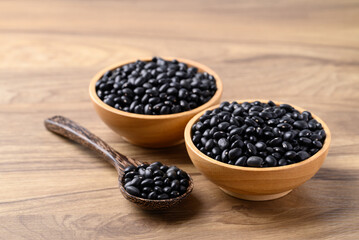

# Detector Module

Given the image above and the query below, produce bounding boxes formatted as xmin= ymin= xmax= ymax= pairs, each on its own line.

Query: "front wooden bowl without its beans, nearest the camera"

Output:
xmin=185 ymin=100 xmax=331 ymax=201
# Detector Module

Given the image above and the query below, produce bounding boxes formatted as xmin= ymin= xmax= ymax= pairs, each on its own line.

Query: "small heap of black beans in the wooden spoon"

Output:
xmin=123 ymin=162 xmax=189 ymax=200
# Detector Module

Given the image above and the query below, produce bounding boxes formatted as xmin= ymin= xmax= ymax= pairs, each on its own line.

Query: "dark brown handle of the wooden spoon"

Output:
xmin=45 ymin=116 xmax=141 ymax=174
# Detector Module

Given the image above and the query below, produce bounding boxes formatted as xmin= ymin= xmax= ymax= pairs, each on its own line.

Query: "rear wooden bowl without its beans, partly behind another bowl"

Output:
xmin=89 ymin=58 xmax=223 ymax=148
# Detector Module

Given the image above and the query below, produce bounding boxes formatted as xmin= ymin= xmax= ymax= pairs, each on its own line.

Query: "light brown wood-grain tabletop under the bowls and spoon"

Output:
xmin=0 ymin=0 xmax=359 ymax=239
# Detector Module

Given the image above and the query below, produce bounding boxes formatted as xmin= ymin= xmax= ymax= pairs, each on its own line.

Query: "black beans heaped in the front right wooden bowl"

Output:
xmin=192 ymin=101 xmax=326 ymax=167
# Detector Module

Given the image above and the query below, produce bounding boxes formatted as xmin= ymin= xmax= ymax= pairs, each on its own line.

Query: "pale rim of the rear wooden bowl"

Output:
xmin=89 ymin=57 xmax=223 ymax=120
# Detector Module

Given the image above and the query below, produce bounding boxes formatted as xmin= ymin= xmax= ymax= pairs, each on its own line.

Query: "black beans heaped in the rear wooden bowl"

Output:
xmin=96 ymin=57 xmax=217 ymax=115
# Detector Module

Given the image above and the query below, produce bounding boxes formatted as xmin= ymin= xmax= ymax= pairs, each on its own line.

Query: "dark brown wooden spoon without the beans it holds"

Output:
xmin=45 ymin=116 xmax=193 ymax=210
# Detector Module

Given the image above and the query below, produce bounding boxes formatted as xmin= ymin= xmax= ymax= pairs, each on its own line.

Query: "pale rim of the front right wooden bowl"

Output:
xmin=184 ymin=99 xmax=331 ymax=172
